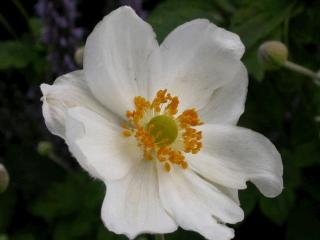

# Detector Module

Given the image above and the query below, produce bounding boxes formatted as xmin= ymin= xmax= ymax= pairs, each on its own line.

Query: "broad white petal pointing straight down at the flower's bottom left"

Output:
xmin=102 ymin=160 xmax=177 ymax=239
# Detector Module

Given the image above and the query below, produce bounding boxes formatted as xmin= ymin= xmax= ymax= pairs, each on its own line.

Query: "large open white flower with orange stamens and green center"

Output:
xmin=41 ymin=7 xmax=283 ymax=240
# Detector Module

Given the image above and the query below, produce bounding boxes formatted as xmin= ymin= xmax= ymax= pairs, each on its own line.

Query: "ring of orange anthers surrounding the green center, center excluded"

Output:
xmin=121 ymin=89 xmax=203 ymax=172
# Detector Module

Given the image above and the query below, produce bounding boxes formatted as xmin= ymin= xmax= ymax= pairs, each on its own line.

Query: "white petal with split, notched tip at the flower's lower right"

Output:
xmin=158 ymin=165 xmax=243 ymax=240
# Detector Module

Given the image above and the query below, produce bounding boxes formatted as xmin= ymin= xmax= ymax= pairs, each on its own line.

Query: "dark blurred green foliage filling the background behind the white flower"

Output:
xmin=0 ymin=0 xmax=320 ymax=240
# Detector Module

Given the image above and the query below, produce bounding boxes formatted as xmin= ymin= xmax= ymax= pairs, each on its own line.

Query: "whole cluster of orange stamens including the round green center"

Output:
xmin=122 ymin=89 xmax=202 ymax=172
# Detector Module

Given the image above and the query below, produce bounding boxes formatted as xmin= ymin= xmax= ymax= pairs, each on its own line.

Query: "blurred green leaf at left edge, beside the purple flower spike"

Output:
xmin=0 ymin=41 xmax=34 ymax=70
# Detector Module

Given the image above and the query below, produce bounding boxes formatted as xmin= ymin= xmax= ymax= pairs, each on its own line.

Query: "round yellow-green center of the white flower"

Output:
xmin=147 ymin=115 xmax=178 ymax=147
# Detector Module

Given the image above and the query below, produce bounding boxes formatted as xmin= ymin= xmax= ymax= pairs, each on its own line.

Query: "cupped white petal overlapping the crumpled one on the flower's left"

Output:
xmin=66 ymin=107 xmax=142 ymax=181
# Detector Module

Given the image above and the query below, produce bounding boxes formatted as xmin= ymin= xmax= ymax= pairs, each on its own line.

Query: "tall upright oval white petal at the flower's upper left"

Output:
xmin=84 ymin=7 xmax=160 ymax=119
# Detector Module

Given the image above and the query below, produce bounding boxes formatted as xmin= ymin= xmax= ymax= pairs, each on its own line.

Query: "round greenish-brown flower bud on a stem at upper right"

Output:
xmin=258 ymin=41 xmax=288 ymax=70
